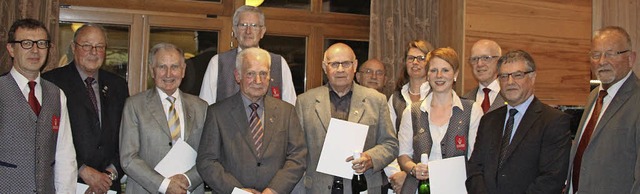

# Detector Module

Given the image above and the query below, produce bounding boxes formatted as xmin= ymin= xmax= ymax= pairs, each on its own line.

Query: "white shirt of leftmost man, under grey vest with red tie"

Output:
xmin=10 ymin=67 xmax=78 ymax=194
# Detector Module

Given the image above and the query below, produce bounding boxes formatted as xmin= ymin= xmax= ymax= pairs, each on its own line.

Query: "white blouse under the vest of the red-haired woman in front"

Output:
xmin=398 ymin=91 xmax=483 ymax=161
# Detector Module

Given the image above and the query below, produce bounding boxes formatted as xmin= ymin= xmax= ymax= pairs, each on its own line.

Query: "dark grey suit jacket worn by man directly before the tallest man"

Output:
xmin=197 ymin=92 xmax=307 ymax=193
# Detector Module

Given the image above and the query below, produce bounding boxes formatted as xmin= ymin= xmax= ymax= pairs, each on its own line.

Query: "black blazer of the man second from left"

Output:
xmin=42 ymin=62 xmax=129 ymax=191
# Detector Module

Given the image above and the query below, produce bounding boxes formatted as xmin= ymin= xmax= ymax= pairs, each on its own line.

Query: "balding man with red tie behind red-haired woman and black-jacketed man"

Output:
xmin=463 ymin=39 xmax=504 ymax=113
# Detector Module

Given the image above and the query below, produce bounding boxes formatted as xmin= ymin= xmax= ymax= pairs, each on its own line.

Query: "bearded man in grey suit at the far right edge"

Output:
xmin=568 ymin=26 xmax=640 ymax=193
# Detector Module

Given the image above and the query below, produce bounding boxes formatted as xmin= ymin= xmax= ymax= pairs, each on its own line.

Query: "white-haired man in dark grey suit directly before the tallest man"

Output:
xmin=197 ymin=47 xmax=307 ymax=194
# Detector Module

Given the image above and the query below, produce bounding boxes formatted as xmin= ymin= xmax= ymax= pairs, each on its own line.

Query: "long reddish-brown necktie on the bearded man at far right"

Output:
xmin=571 ymin=90 xmax=607 ymax=193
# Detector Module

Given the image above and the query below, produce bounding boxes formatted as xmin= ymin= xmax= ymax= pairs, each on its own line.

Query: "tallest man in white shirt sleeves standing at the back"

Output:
xmin=200 ymin=5 xmax=296 ymax=104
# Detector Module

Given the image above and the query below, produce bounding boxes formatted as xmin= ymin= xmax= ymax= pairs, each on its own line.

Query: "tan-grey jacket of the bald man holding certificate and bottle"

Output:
xmin=296 ymin=83 xmax=398 ymax=194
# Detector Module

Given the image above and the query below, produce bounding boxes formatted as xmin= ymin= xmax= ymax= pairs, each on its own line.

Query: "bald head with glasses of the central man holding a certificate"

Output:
xmin=322 ymin=43 xmax=358 ymax=95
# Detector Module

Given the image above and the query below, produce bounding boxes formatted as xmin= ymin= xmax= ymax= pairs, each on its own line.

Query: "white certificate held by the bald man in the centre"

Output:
xmin=316 ymin=118 xmax=369 ymax=179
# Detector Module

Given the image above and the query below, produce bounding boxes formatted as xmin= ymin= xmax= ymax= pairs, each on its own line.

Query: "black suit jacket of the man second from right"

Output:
xmin=466 ymin=97 xmax=571 ymax=194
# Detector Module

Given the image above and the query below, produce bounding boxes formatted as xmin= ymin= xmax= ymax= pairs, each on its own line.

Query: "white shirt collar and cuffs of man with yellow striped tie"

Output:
xmin=156 ymin=87 xmax=191 ymax=193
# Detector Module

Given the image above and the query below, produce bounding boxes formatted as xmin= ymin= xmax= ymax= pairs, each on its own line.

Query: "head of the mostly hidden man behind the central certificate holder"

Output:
xmin=356 ymin=59 xmax=387 ymax=93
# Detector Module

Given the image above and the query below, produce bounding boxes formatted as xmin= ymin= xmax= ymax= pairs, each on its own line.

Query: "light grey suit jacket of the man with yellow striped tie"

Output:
xmin=120 ymin=88 xmax=208 ymax=194
